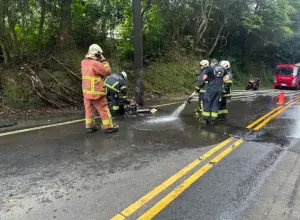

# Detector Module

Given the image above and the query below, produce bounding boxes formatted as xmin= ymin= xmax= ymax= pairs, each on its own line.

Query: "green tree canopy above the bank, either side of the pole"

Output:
xmin=0 ymin=0 xmax=300 ymax=68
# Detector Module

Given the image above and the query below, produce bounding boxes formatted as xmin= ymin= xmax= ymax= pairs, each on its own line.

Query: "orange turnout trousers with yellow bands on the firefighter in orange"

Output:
xmin=84 ymin=96 xmax=113 ymax=129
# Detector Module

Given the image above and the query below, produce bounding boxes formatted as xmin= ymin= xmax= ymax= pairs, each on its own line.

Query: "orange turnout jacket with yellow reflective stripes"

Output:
xmin=81 ymin=58 xmax=111 ymax=99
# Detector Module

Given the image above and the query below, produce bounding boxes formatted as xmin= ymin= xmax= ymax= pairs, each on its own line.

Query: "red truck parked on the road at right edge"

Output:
xmin=273 ymin=63 xmax=300 ymax=89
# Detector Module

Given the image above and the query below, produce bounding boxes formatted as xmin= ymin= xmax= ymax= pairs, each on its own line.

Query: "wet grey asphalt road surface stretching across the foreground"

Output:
xmin=0 ymin=91 xmax=300 ymax=220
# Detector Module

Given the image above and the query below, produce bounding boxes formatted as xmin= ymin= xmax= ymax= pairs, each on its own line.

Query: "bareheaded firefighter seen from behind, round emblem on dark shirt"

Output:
xmin=198 ymin=59 xmax=229 ymax=125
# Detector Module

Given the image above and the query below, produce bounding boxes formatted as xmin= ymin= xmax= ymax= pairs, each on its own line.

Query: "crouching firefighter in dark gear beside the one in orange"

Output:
xmin=104 ymin=71 xmax=129 ymax=115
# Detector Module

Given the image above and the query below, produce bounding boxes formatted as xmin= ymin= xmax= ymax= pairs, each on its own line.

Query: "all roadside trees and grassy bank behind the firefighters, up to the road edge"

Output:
xmin=0 ymin=0 xmax=300 ymax=109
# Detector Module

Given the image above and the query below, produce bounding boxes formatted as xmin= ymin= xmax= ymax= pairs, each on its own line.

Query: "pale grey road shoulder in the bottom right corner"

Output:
xmin=239 ymin=142 xmax=300 ymax=220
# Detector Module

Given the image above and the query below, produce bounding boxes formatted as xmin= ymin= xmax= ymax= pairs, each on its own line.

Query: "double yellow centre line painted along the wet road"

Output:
xmin=111 ymin=98 xmax=300 ymax=220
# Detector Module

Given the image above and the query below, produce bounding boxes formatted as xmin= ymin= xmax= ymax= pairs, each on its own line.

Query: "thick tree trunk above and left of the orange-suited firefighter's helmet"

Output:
xmin=58 ymin=0 xmax=74 ymax=50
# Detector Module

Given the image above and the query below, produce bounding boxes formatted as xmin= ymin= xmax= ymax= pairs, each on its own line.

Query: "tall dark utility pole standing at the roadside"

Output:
xmin=132 ymin=0 xmax=144 ymax=106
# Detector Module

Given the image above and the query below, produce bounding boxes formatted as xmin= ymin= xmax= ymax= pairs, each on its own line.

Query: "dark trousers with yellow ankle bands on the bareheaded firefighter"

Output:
xmin=202 ymin=85 xmax=220 ymax=121
